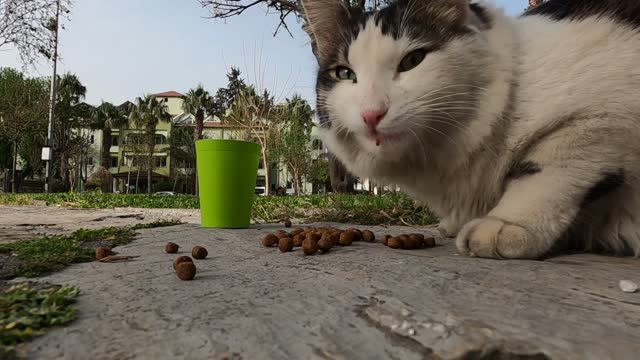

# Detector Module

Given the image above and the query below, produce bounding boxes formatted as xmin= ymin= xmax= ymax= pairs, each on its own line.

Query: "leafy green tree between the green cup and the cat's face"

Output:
xmin=276 ymin=95 xmax=314 ymax=194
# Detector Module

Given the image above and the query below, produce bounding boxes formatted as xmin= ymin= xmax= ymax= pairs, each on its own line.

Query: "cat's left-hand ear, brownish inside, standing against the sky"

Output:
xmin=302 ymin=0 xmax=350 ymax=59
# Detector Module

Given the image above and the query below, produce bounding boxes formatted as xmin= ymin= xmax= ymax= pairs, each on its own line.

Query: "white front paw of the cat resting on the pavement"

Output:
xmin=456 ymin=217 xmax=541 ymax=259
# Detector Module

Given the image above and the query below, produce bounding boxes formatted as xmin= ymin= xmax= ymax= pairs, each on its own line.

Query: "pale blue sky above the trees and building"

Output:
xmin=0 ymin=0 xmax=527 ymax=104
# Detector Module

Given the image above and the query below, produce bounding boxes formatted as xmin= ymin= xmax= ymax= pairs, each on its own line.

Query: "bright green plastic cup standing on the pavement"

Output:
xmin=196 ymin=139 xmax=261 ymax=229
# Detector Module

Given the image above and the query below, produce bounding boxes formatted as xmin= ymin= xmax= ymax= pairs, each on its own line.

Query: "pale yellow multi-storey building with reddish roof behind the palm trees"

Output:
xmin=79 ymin=91 xmax=326 ymax=193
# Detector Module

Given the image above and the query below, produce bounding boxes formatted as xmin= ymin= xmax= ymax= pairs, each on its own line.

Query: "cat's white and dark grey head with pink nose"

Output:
xmin=303 ymin=0 xmax=491 ymax=174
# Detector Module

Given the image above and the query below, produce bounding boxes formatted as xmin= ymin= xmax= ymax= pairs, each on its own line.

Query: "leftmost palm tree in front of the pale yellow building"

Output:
xmin=91 ymin=101 xmax=129 ymax=192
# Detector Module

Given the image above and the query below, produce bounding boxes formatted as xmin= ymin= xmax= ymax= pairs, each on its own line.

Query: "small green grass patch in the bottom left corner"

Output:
xmin=0 ymin=284 xmax=80 ymax=359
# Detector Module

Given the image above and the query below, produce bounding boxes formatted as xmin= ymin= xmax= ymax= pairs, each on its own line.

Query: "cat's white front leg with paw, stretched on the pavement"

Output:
xmin=456 ymin=166 xmax=624 ymax=259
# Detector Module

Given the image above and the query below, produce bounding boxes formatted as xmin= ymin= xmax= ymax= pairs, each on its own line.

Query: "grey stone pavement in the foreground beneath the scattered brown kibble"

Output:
xmin=15 ymin=224 xmax=640 ymax=360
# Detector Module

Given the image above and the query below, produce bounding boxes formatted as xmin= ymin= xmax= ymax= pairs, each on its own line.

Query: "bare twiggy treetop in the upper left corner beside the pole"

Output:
xmin=0 ymin=0 xmax=72 ymax=65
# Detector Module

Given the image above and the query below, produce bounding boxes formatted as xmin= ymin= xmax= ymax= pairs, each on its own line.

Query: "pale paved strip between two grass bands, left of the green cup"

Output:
xmin=0 ymin=205 xmax=200 ymax=243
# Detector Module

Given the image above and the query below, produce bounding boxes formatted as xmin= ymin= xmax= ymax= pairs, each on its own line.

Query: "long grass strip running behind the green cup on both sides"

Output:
xmin=0 ymin=192 xmax=437 ymax=225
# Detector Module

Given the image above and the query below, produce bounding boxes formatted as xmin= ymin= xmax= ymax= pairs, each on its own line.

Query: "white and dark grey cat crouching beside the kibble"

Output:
xmin=302 ymin=0 xmax=640 ymax=259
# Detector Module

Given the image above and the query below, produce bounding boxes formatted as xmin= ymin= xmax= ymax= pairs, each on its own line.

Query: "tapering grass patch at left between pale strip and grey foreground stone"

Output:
xmin=0 ymin=220 xmax=181 ymax=278
